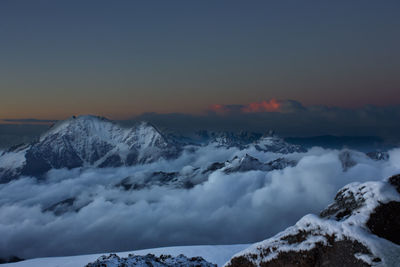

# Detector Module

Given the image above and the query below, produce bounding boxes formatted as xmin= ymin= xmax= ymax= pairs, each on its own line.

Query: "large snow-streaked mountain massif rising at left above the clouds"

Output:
xmin=0 ymin=116 xmax=180 ymax=182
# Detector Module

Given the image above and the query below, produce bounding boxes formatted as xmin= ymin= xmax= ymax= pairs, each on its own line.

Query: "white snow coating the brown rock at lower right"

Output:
xmin=227 ymin=182 xmax=400 ymax=266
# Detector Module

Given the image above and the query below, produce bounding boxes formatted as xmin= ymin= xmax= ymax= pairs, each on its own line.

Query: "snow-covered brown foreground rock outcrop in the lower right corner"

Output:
xmin=225 ymin=175 xmax=400 ymax=267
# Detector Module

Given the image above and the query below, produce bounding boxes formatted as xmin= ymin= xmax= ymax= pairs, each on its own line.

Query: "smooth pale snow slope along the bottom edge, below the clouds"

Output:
xmin=0 ymin=244 xmax=250 ymax=267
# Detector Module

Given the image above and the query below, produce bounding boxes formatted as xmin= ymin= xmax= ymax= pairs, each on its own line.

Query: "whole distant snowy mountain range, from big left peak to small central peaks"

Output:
xmin=0 ymin=115 xmax=305 ymax=183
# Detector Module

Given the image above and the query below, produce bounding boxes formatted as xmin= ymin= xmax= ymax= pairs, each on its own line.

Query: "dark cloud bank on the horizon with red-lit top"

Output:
xmin=133 ymin=99 xmax=400 ymax=144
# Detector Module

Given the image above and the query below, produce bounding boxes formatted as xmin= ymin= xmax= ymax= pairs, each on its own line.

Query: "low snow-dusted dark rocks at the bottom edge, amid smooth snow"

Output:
xmin=85 ymin=254 xmax=217 ymax=267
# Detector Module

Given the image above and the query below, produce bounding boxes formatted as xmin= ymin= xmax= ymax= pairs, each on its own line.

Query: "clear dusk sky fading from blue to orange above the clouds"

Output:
xmin=0 ymin=0 xmax=400 ymax=119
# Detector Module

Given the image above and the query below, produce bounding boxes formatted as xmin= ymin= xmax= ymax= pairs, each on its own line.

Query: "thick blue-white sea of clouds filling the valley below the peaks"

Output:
xmin=0 ymin=146 xmax=400 ymax=258
